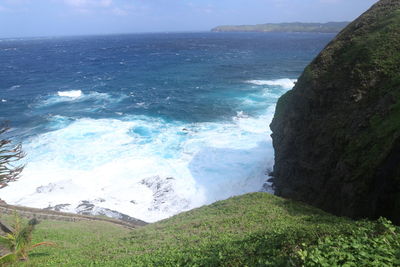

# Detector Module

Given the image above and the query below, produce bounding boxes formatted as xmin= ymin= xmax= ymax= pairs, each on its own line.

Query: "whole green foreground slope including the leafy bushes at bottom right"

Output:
xmin=0 ymin=193 xmax=400 ymax=267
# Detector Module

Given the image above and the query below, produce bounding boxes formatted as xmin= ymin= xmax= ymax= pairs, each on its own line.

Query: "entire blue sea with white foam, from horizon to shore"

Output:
xmin=0 ymin=33 xmax=333 ymax=221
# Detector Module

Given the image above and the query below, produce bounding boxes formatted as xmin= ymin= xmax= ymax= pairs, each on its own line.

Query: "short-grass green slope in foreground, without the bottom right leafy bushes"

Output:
xmin=3 ymin=193 xmax=400 ymax=266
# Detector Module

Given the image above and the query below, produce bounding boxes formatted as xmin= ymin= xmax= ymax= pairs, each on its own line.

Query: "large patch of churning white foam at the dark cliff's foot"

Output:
xmin=0 ymin=78 xmax=296 ymax=222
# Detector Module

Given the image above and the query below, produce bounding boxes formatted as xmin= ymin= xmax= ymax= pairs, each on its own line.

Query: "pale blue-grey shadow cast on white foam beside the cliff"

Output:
xmin=189 ymin=141 xmax=274 ymax=203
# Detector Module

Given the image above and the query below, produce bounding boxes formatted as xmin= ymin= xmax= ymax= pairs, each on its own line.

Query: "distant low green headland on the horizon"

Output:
xmin=211 ymin=21 xmax=349 ymax=33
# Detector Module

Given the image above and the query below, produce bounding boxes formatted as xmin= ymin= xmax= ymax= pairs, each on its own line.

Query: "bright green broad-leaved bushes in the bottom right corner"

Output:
xmin=297 ymin=218 xmax=400 ymax=266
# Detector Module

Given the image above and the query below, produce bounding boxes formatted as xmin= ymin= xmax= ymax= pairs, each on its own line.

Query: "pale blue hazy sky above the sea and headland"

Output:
xmin=0 ymin=0 xmax=377 ymax=38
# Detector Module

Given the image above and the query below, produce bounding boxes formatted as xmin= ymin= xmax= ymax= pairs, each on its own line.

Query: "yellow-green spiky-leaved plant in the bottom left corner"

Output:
xmin=0 ymin=215 xmax=55 ymax=265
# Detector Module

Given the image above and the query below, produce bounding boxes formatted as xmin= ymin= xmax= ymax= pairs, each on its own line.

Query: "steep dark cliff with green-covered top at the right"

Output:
xmin=271 ymin=0 xmax=400 ymax=223
